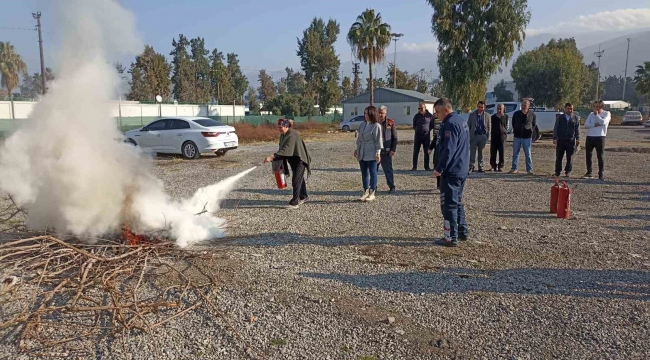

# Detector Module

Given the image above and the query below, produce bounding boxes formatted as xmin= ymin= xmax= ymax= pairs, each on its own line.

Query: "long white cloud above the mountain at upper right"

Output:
xmin=526 ymin=8 xmax=650 ymax=36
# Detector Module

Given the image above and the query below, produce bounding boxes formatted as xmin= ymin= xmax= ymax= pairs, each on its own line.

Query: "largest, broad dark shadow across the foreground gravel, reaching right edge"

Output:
xmin=300 ymin=268 xmax=650 ymax=301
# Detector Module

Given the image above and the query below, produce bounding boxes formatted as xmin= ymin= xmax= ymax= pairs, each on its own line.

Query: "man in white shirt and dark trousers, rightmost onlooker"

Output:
xmin=583 ymin=100 xmax=612 ymax=180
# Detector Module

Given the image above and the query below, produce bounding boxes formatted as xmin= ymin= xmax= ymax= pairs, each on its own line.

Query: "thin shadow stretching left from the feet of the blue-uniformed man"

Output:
xmin=211 ymin=230 xmax=436 ymax=247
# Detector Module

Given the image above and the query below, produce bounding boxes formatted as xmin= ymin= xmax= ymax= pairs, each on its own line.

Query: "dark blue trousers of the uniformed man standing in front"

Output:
xmin=440 ymin=175 xmax=469 ymax=243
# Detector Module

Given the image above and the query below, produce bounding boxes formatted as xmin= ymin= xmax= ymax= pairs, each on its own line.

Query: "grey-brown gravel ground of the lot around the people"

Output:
xmin=0 ymin=127 xmax=650 ymax=360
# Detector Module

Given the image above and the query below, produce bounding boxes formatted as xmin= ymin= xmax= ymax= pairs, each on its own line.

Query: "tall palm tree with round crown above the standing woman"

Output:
xmin=347 ymin=9 xmax=391 ymax=105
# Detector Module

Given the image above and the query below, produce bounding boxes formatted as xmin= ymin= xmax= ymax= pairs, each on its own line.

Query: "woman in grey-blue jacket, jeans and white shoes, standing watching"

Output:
xmin=354 ymin=105 xmax=383 ymax=201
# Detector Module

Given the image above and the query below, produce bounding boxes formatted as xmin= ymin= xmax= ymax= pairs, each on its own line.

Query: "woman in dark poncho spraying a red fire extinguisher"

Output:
xmin=264 ymin=119 xmax=311 ymax=209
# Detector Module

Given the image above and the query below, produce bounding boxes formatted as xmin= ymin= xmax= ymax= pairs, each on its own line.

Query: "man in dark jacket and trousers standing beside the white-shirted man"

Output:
xmin=553 ymin=103 xmax=580 ymax=177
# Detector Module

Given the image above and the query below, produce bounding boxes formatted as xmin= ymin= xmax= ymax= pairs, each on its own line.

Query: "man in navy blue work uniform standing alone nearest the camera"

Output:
xmin=433 ymin=98 xmax=469 ymax=246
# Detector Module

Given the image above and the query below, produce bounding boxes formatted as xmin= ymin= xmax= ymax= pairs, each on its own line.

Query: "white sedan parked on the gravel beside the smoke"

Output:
xmin=124 ymin=116 xmax=239 ymax=159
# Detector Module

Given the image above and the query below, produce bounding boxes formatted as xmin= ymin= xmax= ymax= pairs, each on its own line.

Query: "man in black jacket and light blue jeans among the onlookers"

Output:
xmin=510 ymin=100 xmax=537 ymax=175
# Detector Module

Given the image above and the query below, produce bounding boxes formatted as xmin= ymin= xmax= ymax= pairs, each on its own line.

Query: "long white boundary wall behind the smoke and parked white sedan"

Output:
xmin=0 ymin=101 xmax=245 ymax=119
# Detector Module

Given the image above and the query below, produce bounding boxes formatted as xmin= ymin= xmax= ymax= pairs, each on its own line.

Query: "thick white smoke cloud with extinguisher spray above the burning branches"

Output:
xmin=0 ymin=0 xmax=252 ymax=246
